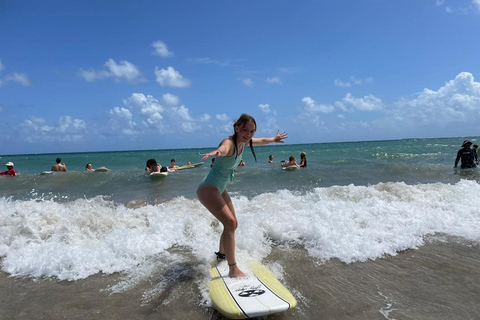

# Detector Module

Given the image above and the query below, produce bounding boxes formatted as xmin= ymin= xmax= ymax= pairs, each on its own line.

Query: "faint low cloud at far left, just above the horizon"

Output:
xmin=21 ymin=116 xmax=87 ymax=143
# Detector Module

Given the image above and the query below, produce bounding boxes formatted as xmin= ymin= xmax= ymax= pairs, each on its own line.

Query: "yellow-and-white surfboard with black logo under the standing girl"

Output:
xmin=209 ymin=261 xmax=297 ymax=319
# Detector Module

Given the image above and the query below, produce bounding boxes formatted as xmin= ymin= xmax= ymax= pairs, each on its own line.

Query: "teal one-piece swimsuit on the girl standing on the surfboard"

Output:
xmin=197 ymin=137 xmax=245 ymax=194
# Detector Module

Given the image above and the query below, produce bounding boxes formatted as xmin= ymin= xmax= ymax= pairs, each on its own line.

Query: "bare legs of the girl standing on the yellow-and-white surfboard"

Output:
xmin=197 ymin=184 xmax=244 ymax=277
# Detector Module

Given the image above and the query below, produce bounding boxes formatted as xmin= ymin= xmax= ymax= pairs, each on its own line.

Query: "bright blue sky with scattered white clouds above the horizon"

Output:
xmin=0 ymin=0 xmax=480 ymax=155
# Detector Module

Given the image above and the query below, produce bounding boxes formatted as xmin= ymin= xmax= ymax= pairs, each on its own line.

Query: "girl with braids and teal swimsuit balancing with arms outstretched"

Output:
xmin=197 ymin=113 xmax=288 ymax=277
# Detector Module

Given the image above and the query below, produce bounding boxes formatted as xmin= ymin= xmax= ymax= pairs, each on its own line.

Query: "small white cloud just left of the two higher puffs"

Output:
xmin=78 ymin=59 xmax=145 ymax=83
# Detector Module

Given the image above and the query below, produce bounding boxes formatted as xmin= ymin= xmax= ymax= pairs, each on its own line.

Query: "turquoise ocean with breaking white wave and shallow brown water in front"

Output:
xmin=0 ymin=137 xmax=480 ymax=319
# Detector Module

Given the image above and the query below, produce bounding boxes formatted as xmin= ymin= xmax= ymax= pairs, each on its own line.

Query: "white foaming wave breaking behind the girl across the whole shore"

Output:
xmin=0 ymin=180 xmax=480 ymax=280
